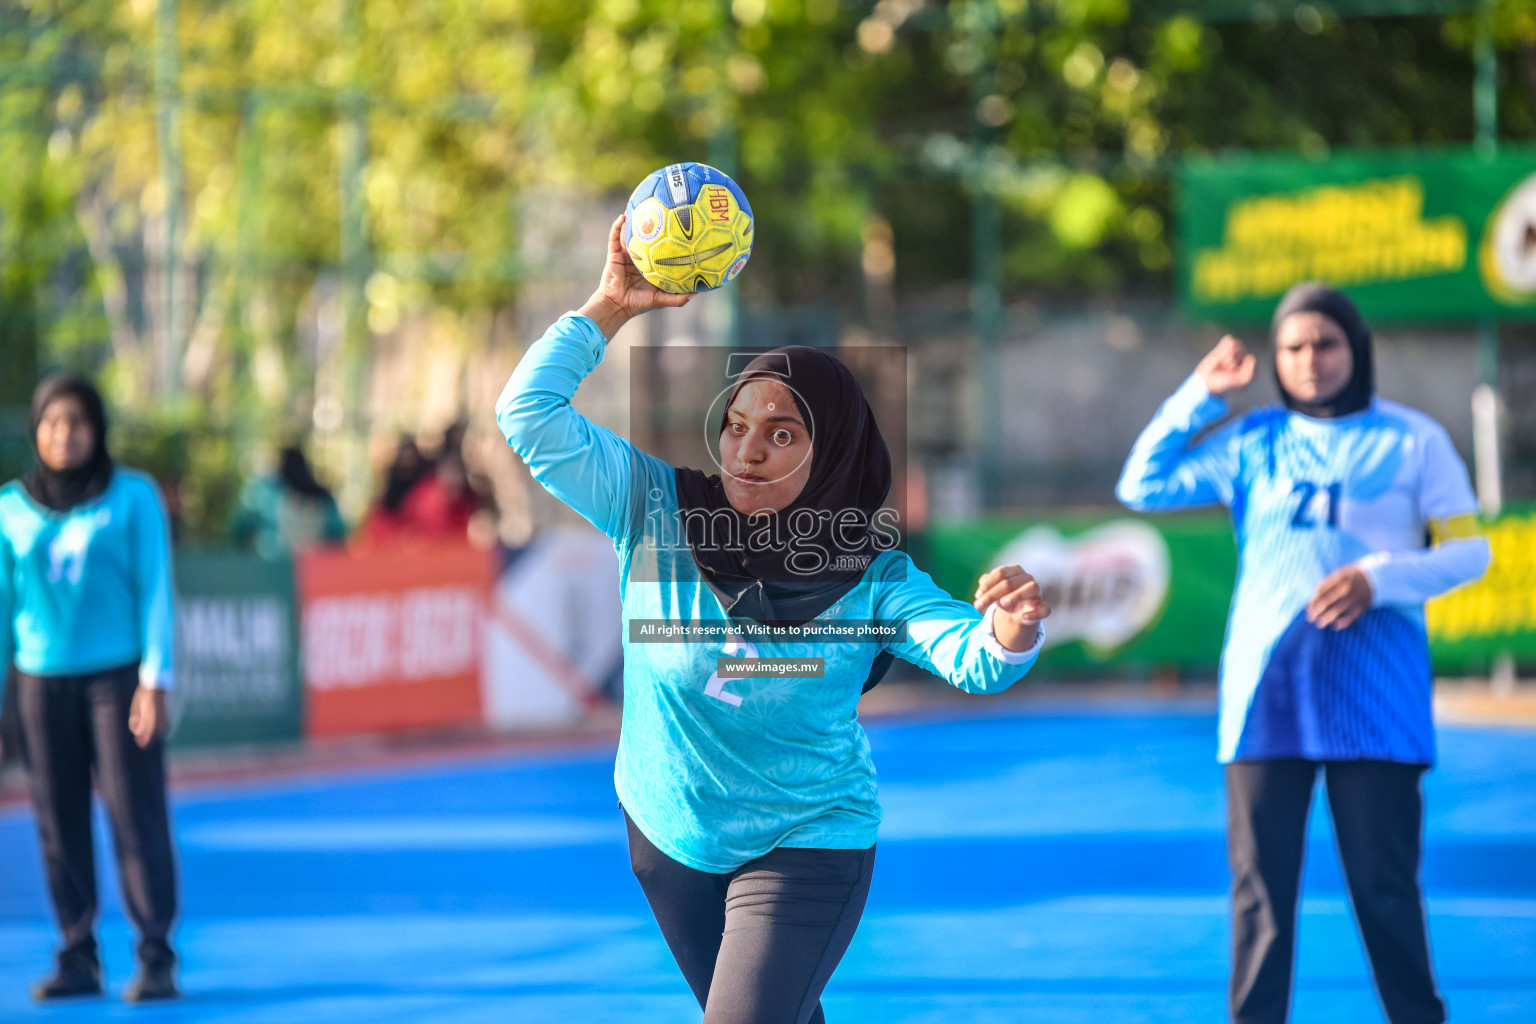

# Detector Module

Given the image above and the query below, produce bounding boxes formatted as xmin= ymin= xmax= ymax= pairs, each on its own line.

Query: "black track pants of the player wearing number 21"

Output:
xmin=1227 ymin=758 xmax=1445 ymax=1024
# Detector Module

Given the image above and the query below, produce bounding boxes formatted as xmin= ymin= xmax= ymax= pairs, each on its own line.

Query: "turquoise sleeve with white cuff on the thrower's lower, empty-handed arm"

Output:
xmin=874 ymin=554 xmax=1044 ymax=694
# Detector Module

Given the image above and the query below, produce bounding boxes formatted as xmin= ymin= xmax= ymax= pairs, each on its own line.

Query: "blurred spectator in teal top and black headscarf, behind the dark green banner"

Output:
xmin=230 ymin=445 xmax=347 ymax=559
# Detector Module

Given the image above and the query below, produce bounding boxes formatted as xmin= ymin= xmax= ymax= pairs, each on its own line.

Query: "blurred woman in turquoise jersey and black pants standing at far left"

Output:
xmin=0 ymin=375 xmax=177 ymax=1003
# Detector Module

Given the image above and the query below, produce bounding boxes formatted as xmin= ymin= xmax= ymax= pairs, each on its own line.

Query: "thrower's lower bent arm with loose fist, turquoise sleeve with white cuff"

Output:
xmin=876 ymin=554 xmax=1051 ymax=694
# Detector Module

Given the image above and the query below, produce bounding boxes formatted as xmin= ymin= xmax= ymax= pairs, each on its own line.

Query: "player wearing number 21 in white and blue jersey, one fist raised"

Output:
xmin=1117 ymin=284 xmax=1488 ymax=1024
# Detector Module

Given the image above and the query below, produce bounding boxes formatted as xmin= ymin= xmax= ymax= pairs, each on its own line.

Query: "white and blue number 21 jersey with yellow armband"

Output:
xmin=1117 ymin=375 xmax=1488 ymax=765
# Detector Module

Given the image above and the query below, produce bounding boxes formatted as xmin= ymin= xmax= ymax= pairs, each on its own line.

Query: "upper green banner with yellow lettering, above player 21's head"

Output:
xmin=1178 ymin=147 xmax=1536 ymax=321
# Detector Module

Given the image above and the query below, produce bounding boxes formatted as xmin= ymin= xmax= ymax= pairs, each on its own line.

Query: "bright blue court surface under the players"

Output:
xmin=0 ymin=705 xmax=1536 ymax=1024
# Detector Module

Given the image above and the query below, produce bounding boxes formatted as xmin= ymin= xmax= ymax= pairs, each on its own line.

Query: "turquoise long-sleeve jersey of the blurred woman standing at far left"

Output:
xmin=0 ymin=467 xmax=175 ymax=689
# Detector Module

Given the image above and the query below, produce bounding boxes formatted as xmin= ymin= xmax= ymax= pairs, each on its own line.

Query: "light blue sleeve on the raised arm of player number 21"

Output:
xmin=1115 ymin=373 xmax=1241 ymax=511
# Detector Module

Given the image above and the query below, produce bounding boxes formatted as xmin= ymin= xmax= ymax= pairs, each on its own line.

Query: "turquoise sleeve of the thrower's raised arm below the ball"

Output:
xmin=496 ymin=313 xmax=664 ymax=540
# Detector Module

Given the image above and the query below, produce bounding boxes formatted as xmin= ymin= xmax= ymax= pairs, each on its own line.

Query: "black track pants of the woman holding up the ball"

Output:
xmin=625 ymin=815 xmax=874 ymax=1024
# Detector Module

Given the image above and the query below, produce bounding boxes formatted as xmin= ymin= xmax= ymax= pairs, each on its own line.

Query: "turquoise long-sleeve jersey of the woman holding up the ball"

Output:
xmin=496 ymin=315 xmax=1043 ymax=872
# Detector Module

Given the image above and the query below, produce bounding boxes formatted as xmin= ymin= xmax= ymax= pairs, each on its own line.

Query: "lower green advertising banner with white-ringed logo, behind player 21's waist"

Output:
xmin=925 ymin=508 xmax=1536 ymax=676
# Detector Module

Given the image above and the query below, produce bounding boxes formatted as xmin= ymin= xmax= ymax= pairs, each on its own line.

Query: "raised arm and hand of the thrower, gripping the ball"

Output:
xmin=496 ymin=216 xmax=693 ymax=540
